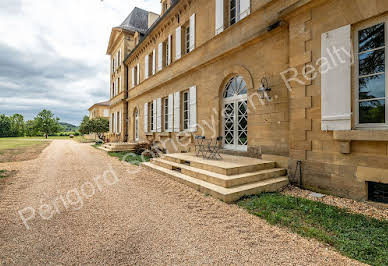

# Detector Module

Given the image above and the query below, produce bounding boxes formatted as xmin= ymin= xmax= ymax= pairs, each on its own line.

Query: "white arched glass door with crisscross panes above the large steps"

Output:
xmin=223 ymin=76 xmax=248 ymax=151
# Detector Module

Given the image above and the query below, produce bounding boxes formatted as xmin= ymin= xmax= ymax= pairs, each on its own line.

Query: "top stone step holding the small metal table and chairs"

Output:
xmin=163 ymin=153 xmax=276 ymax=175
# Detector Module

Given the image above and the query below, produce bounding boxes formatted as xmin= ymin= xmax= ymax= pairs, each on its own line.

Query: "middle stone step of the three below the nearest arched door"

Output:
xmin=152 ymin=158 xmax=287 ymax=188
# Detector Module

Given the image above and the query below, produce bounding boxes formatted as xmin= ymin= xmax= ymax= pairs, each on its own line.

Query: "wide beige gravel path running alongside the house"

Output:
xmin=0 ymin=140 xmax=364 ymax=265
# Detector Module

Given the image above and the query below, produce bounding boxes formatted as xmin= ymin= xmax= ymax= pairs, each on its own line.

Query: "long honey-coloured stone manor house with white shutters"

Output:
xmin=103 ymin=0 xmax=388 ymax=202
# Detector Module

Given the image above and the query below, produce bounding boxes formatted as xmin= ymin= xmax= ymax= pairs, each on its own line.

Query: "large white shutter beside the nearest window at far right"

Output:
xmin=321 ymin=25 xmax=352 ymax=130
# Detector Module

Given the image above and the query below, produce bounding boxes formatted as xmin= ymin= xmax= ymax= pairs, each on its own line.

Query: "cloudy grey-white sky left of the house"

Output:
xmin=0 ymin=0 xmax=160 ymax=125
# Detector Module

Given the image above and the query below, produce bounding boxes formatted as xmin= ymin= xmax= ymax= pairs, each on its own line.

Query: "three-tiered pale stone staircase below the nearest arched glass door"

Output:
xmin=142 ymin=153 xmax=288 ymax=203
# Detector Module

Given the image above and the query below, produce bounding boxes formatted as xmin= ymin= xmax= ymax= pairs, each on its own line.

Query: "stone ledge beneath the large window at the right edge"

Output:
xmin=333 ymin=130 xmax=388 ymax=141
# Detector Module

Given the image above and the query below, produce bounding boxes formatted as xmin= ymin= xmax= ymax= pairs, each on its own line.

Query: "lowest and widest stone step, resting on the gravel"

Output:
xmin=141 ymin=162 xmax=288 ymax=203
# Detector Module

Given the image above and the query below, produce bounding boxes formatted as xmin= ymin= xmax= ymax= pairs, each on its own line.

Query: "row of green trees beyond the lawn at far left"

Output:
xmin=0 ymin=109 xmax=62 ymax=138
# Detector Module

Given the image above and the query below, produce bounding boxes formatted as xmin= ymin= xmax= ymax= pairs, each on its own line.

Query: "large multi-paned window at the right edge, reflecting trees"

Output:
xmin=356 ymin=22 xmax=388 ymax=127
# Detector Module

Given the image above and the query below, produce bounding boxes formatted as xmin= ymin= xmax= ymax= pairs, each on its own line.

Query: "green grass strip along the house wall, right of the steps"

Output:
xmin=237 ymin=193 xmax=388 ymax=265
